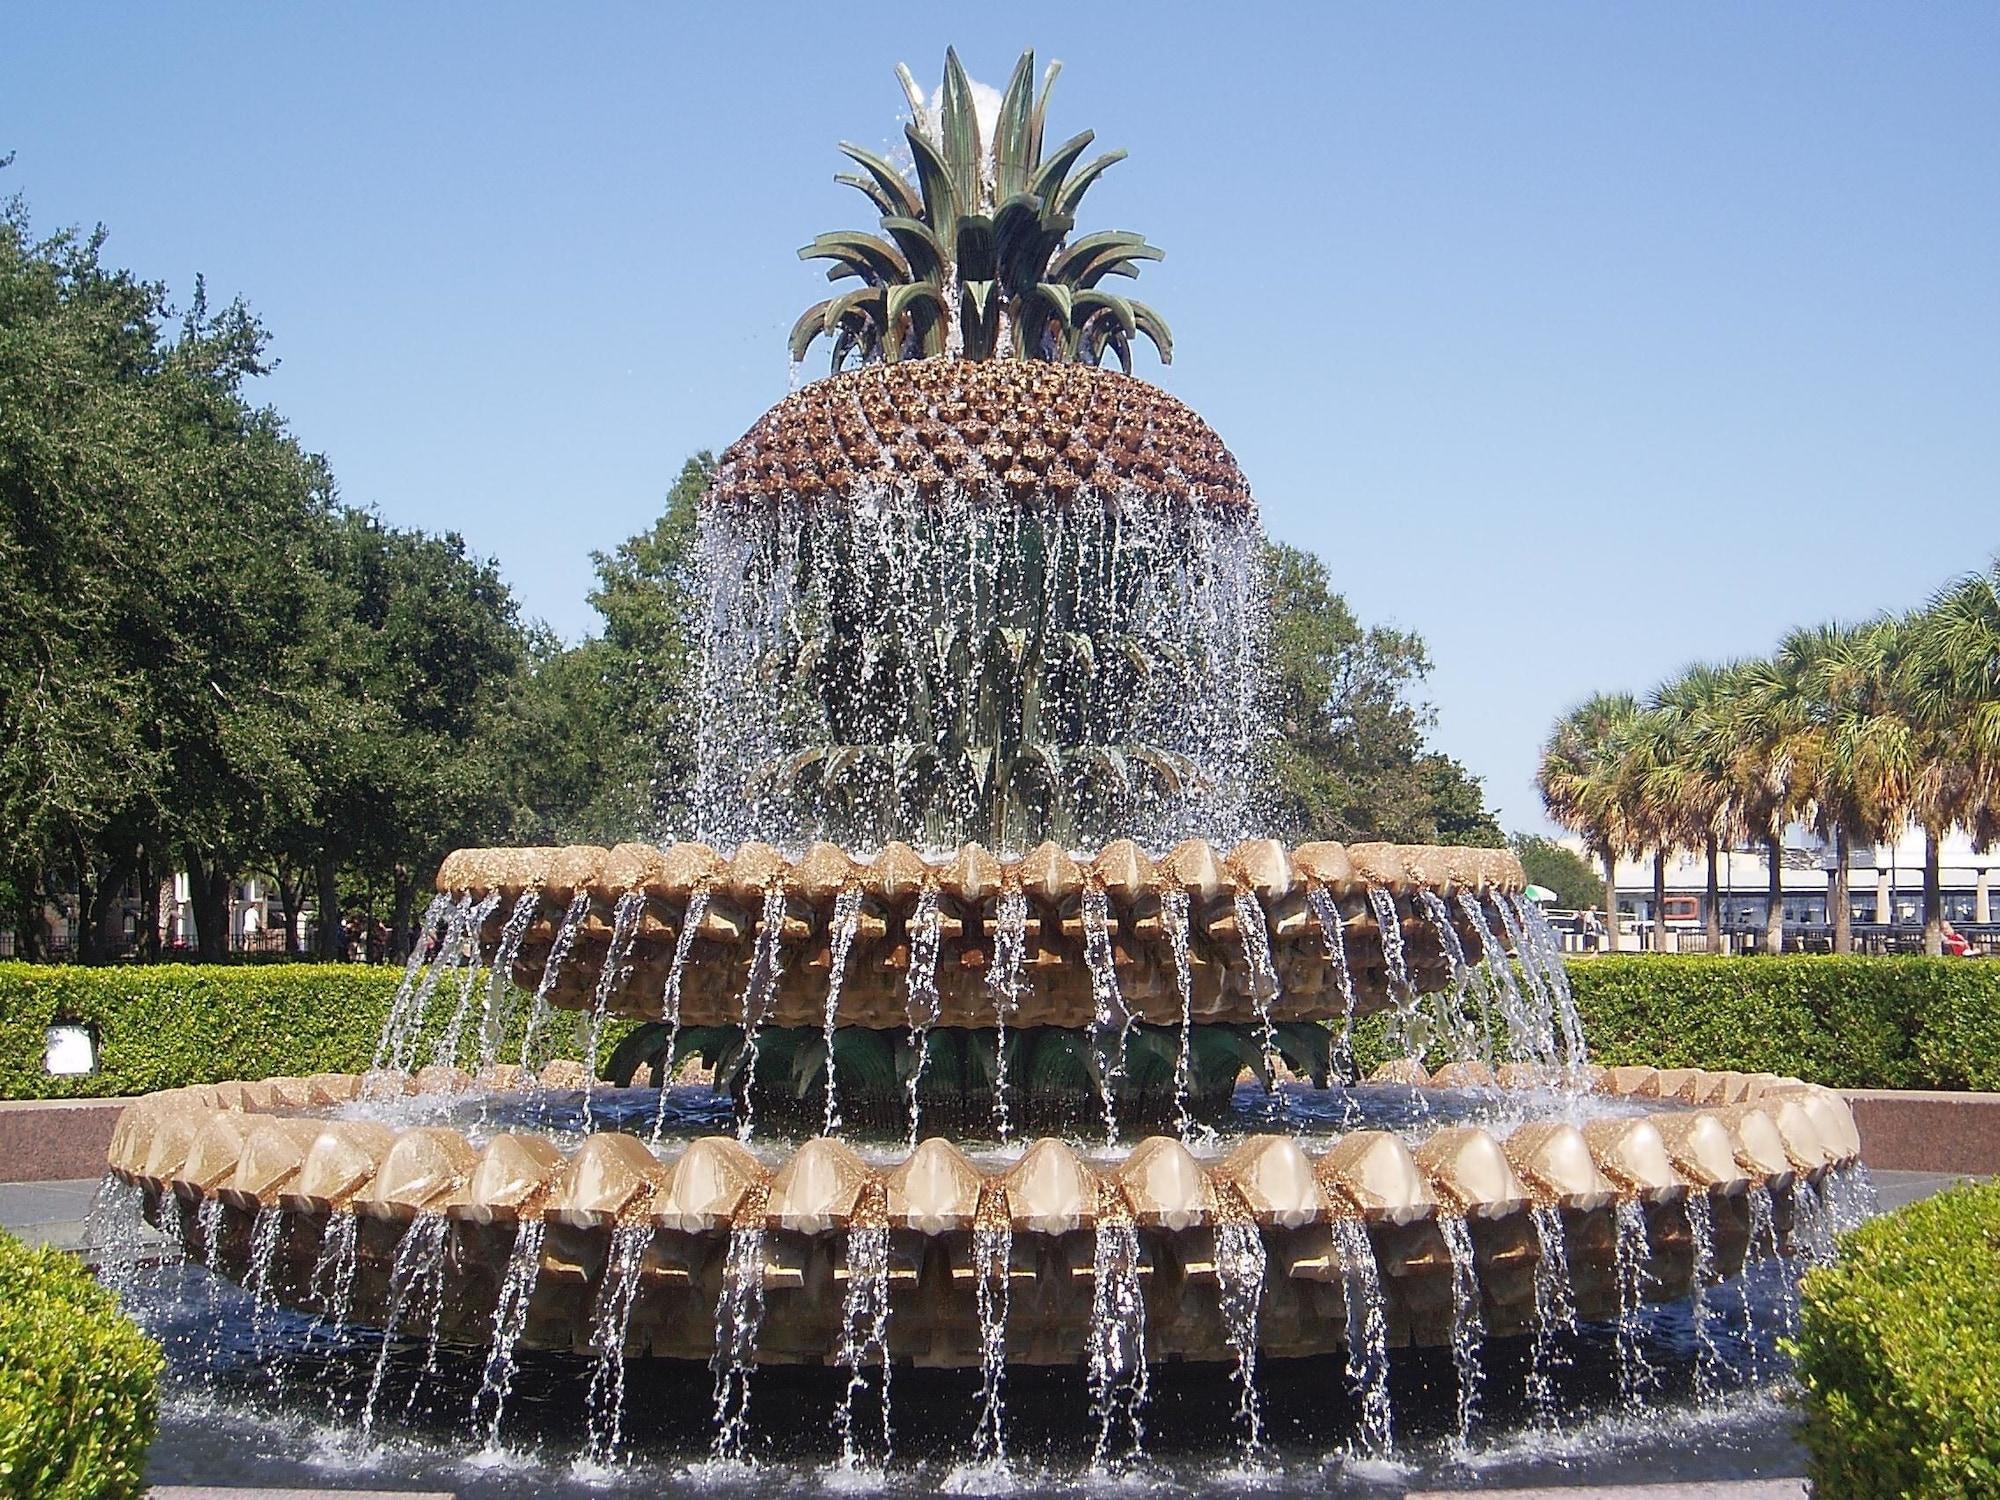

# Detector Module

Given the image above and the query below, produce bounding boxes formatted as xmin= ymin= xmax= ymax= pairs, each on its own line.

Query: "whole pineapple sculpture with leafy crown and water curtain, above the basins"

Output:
xmin=696 ymin=52 xmax=1260 ymax=852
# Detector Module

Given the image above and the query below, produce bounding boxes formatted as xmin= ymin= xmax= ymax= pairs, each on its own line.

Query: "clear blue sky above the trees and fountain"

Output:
xmin=0 ymin=2 xmax=2000 ymax=826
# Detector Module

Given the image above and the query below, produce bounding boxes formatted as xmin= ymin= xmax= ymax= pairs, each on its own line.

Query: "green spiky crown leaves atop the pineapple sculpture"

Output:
xmin=790 ymin=50 xmax=1174 ymax=374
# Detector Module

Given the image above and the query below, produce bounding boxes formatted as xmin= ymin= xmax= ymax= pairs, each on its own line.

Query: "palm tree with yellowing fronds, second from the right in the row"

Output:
xmin=1772 ymin=620 xmax=1908 ymax=954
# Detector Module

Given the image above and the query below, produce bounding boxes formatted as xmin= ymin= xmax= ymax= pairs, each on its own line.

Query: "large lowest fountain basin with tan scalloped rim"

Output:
xmin=110 ymin=1064 xmax=1860 ymax=1364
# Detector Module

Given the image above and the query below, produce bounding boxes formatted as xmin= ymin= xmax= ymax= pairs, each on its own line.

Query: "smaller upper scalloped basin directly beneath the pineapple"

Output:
xmin=438 ymin=840 xmax=1522 ymax=1028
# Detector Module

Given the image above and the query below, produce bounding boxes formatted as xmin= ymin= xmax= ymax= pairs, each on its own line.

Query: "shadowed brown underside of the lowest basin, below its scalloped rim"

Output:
xmin=146 ymin=1178 xmax=1840 ymax=1368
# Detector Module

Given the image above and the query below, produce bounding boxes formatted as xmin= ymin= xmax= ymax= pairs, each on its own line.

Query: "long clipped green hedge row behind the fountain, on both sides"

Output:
xmin=0 ymin=954 xmax=2000 ymax=1098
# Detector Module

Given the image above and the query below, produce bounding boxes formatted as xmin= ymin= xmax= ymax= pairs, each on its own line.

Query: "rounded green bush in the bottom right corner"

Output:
xmin=1792 ymin=1184 xmax=2000 ymax=1496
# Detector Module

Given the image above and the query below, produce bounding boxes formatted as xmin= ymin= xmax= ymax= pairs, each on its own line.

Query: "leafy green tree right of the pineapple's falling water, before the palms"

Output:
xmin=1266 ymin=542 xmax=1502 ymax=846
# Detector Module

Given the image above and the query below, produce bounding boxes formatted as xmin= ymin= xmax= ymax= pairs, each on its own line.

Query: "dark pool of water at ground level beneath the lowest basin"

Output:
xmin=124 ymin=1224 xmax=1802 ymax=1500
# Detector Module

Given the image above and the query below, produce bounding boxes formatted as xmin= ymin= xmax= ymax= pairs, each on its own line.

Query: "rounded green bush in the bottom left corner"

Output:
xmin=0 ymin=1234 xmax=162 ymax=1500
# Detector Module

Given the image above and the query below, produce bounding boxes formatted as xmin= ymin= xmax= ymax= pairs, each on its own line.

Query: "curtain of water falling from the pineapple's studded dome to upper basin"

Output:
xmin=692 ymin=488 xmax=1264 ymax=850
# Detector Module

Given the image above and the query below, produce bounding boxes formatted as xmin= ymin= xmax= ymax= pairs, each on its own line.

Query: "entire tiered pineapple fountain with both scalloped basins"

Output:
xmin=110 ymin=44 xmax=1866 ymax=1462
